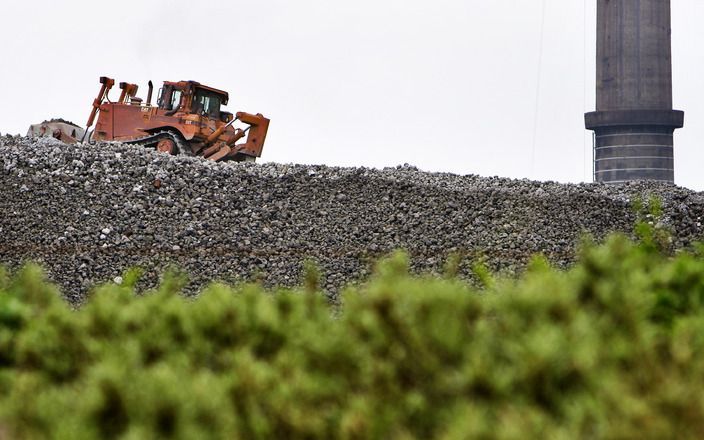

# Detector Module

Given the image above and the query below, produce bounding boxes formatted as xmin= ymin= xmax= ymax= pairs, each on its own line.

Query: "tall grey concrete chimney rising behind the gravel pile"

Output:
xmin=584 ymin=0 xmax=684 ymax=183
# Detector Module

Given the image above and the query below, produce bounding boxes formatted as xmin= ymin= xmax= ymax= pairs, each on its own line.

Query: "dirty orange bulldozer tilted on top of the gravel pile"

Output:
xmin=82 ymin=77 xmax=269 ymax=162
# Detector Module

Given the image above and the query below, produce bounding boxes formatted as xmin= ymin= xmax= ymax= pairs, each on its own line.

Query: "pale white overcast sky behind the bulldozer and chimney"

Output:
xmin=5 ymin=0 xmax=704 ymax=190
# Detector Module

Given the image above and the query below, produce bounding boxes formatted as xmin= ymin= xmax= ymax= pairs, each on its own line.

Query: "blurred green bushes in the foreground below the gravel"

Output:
xmin=0 ymin=236 xmax=704 ymax=439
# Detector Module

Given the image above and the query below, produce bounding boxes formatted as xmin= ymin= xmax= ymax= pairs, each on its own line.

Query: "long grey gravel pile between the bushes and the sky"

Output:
xmin=0 ymin=137 xmax=704 ymax=303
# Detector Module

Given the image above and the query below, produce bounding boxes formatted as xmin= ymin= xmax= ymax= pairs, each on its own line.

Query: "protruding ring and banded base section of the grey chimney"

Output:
xmin=584 ymin=110 xmax=684 ymax=183
